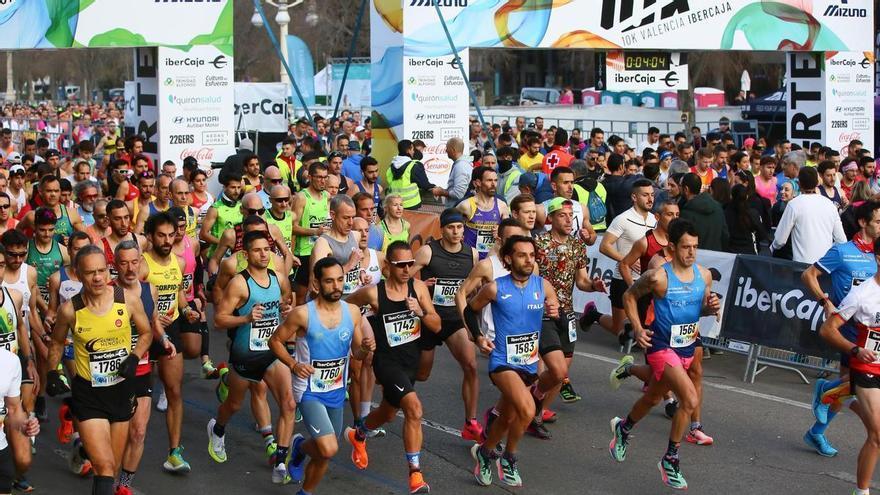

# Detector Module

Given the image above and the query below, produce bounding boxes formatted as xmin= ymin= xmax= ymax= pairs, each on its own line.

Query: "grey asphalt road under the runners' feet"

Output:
xmin=29 ymin=330 xmax=865 ymax=495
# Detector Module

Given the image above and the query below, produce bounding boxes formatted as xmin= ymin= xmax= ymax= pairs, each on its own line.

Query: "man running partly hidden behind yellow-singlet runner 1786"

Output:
xmin=113 ymin=240 xmax=177 ymax=495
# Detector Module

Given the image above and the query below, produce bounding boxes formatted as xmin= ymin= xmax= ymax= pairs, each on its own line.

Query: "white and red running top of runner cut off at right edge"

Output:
xmin=835 ymin=277 xmax=880 ymax=375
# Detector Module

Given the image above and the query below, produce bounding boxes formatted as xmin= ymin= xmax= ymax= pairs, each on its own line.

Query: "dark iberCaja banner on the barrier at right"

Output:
xmin=723 ymin=255 xmax=836 ymax=357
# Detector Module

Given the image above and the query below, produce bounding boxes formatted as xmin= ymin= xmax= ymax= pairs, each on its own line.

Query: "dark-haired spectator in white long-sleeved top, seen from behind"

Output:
xmin=771 ymin=167 xmax=846 ymax=263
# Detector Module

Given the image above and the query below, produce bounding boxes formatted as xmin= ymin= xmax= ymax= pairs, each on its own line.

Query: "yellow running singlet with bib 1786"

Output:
xmin=72 ymin=287 xmax=132 ymax=387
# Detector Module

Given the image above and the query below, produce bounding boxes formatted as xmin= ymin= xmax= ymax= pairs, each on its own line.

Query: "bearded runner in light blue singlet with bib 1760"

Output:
xmin=269 ymin=258 xmax=376 ymax=494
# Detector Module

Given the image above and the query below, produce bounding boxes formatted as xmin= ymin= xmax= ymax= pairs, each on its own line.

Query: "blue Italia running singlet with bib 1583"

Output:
xmin=489 ymin=275 xmax=544 ymax=374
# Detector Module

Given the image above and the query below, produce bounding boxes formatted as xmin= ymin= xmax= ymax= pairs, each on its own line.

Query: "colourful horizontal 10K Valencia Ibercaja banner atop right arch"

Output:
xmin=398 ymin=0 xmax=876 ymax=53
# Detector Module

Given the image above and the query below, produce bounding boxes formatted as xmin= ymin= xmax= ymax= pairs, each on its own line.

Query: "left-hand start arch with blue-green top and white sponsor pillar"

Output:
xmin=0 ymin=0 xmax=235 ymax=164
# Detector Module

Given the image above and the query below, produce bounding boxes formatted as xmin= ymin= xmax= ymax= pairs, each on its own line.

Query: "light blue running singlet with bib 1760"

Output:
xmin=293 ymin=300 xmax=354 ymax=409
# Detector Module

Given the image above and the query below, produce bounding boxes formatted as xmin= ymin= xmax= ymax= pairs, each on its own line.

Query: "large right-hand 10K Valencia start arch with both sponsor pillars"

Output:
xmin=370 ymin=0 xmax=875 ymax=185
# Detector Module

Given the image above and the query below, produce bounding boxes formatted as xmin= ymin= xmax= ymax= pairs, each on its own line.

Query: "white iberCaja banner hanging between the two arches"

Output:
xmin=234 ymin=82 xmax=290 ymax=132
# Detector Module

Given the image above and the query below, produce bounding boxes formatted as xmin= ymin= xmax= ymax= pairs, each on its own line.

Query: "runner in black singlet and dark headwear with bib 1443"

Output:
xmin=413 ymin=207 xmax=482 ymax=442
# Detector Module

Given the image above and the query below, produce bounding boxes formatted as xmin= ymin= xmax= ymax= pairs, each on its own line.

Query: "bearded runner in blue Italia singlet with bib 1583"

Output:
xmin=464 ymin=236 xmax=559 ymax=486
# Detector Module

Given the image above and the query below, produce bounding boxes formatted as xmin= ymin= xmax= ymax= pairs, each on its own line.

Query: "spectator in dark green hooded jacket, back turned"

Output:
xmin=681 ymin=172 xmax=729 ymax=251
